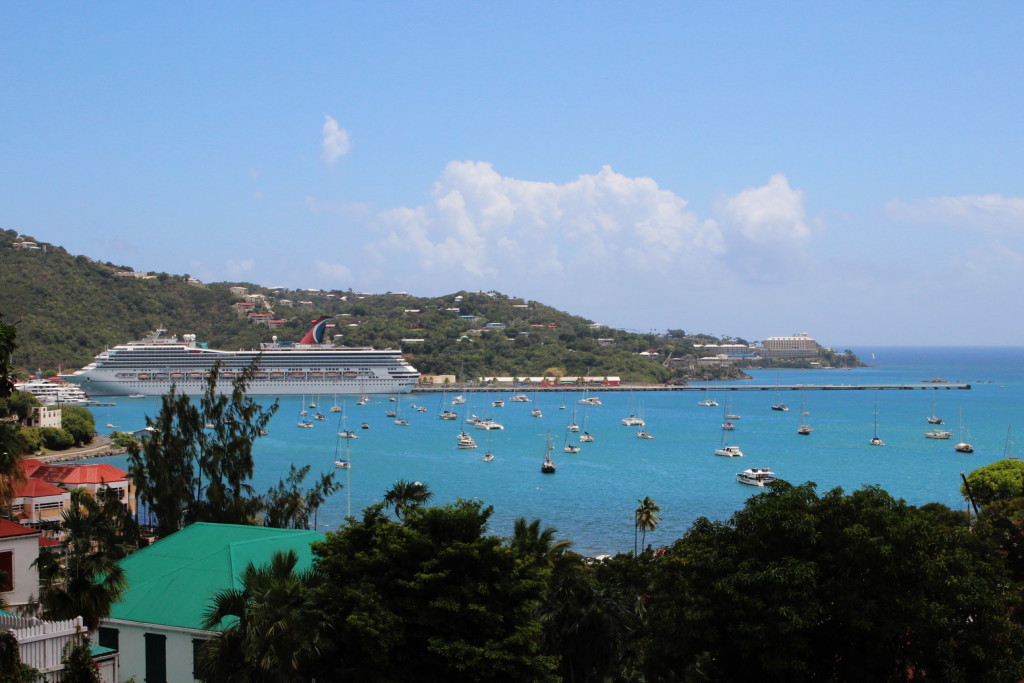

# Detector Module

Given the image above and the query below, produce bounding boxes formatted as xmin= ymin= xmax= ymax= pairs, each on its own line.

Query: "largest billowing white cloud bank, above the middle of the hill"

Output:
xmin=366 ymin=161 xmax=724 ymax=279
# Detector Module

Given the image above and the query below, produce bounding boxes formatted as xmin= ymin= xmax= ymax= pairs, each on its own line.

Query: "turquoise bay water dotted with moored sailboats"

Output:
xmin=81 ymin=347 xmax=1024 ymax=554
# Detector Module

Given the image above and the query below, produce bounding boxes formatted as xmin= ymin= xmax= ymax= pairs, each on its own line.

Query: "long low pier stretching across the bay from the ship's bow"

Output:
xmin=413 ymin=382 xmax=971 ymax=393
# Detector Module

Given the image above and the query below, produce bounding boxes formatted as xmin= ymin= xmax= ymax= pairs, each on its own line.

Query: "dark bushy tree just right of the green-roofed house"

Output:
xmin=313 ymin=493 xmax=554 ymax=683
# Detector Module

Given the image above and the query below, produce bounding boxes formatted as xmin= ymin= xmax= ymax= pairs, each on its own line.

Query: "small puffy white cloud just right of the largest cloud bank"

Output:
xmin=715 ymin=173 xmax=811 ymax=246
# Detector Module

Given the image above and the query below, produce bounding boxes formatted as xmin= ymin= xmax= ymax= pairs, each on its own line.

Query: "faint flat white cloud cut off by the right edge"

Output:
xmin=886 ymin=195 xmax=1024 ymax=236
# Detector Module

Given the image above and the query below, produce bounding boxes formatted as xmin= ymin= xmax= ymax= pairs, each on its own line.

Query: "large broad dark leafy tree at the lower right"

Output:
xmin=645 ymin=482 xmax=1024 ymax=681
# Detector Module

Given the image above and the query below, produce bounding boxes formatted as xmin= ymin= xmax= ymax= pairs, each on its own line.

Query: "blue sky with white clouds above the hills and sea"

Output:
xmin=0 ymin=2 xmax=1024 ymax=348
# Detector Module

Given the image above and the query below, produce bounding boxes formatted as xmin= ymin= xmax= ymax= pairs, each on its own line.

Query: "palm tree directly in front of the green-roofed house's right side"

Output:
xmin=200 ymin=550 xmax=322 ymax=683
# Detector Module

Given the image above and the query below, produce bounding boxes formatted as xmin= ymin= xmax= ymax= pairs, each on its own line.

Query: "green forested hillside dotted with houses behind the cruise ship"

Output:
xmin=0 ymin=230 xmax=688 ymax=382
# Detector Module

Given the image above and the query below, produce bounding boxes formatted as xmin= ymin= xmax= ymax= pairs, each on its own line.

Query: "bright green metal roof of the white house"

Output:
xmin=111 ymin=522 xmax=324 ymax=629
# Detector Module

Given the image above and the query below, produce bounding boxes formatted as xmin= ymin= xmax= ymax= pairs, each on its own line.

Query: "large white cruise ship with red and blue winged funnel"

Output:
xmin=61 ymin=316 xmax=420 ymax=396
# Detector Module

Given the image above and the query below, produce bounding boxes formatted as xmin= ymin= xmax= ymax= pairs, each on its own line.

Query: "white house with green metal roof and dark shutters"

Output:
xmin=98 ymin=522 xmax=324 ymax=683
